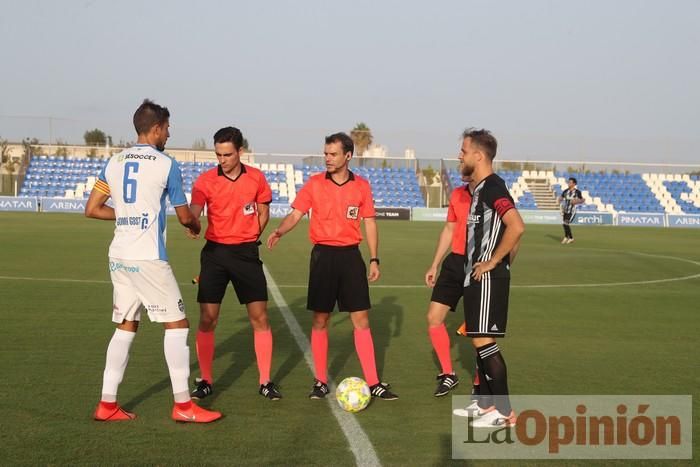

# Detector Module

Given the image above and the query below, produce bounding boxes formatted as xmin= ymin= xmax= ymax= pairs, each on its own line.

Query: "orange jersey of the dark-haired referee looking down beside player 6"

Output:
xmin=192 ymin=164 xmax=272 ymax=245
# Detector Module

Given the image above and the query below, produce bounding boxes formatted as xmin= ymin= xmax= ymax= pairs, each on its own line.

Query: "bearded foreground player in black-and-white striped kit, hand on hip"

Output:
xmin=460 ymin=128 xmax=525 ymax=427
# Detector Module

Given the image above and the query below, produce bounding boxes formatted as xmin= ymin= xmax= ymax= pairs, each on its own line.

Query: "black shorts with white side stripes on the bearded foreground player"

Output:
xmin=464 ymin=273 xmax=510 ymax=337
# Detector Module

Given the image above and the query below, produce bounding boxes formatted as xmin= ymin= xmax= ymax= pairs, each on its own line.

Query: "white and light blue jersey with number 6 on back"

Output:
xmin=94 ymin=144 xmax=187 ymax=261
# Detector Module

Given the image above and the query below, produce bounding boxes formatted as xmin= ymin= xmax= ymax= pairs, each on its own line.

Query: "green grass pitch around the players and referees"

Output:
xmin=0 ymin=213 xmax=700 ymax=466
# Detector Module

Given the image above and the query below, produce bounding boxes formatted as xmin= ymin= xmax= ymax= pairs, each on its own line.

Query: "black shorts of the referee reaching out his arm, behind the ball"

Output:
xmin=306 ymin=245 xmax=372 ymax=313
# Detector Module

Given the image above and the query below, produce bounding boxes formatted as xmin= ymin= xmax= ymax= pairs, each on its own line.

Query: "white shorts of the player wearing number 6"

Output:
xmin=109 ymin=258 xmax=186 ymax=324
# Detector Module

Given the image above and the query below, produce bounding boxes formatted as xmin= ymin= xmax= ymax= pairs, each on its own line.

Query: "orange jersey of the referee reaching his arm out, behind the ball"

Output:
xmin=292 ymin=172 xmax=375 ymax=246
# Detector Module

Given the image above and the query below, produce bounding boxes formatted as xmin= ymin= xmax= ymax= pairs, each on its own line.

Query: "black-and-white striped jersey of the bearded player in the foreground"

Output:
xmin=464 ymin=174 xmax=515 ymax=287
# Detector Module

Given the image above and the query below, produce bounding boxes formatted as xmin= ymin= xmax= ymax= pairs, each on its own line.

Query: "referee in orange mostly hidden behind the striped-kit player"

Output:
xmin=425 ymin=174 xmax=478 ymax=397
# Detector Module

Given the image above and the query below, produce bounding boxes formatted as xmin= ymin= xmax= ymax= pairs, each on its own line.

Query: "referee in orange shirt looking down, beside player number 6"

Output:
xmin=188 ymin=127 xmax=282 ymax=400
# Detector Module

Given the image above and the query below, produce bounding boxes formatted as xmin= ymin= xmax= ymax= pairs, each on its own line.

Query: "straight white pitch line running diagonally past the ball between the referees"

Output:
xmin=263 ymin=265 xmax=382 ymax=466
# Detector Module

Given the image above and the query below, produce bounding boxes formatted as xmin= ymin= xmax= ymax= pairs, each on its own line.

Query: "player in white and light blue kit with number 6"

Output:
xmin=85 ymin=100 xmax=221 ymax=423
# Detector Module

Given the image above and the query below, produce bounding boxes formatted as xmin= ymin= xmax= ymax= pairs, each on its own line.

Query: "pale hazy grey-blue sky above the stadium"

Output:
xmin=0 ymin=0 xmax=700 ymax=164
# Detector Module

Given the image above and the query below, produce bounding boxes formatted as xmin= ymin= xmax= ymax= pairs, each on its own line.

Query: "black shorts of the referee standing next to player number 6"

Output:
xmin=197 ymin=240 xmax=267 ymax=305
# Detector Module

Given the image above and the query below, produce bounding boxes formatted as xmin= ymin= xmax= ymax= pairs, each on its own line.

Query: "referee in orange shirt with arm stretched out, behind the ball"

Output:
xmin=267 ymin=133 xmax=398 ymax=400
